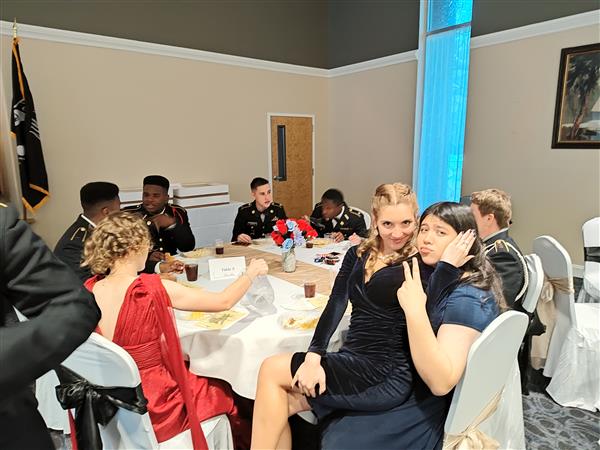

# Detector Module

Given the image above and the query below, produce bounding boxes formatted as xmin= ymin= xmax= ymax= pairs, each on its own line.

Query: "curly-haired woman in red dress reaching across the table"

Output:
xmin=83 ymin=212 xmax=267 ymax=449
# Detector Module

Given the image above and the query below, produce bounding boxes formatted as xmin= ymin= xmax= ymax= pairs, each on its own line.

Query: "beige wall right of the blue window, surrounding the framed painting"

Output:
xmin=463 ymin=26 xmax=600 ymax=264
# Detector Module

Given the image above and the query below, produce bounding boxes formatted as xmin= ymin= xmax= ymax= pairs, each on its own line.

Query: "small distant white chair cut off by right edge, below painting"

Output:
xmin=577 ymin=217 xmax=600 ymax=303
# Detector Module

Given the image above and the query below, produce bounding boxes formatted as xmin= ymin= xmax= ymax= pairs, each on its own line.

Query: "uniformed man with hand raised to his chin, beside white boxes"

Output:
xmin=124 ymin=175 xmax=196 ymax=273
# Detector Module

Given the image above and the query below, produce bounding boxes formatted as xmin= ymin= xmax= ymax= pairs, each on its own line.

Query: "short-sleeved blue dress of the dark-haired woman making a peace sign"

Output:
xmin=321 ymin=263 xmax=498 ymax=450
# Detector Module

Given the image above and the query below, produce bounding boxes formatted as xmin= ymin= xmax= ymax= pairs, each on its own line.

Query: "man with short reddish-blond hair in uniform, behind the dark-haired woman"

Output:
xmin=471 ymin=189 xmax=546 ymax=395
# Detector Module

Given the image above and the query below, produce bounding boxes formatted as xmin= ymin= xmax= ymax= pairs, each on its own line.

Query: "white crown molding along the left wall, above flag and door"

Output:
xmin=0 ymin=20 xmax=328 ymax=77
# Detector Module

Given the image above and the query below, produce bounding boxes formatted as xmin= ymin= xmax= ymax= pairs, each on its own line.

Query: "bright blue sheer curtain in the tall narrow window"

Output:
xmin=415 ymin=0 xmax=472 ymax=210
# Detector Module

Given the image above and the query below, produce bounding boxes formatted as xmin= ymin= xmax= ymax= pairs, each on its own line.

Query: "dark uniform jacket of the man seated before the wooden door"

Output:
xmin=231 ymin=201 xmax=287 ymax=242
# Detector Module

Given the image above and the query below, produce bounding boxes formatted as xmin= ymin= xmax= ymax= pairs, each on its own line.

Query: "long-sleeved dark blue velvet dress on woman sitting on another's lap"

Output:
xmin=291 ymin=247 xmax=440 ymax=418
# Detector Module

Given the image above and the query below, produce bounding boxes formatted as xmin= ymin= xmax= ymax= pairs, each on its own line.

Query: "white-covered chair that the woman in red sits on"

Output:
xmin=36 ymin=333 xmax=233 ymax=450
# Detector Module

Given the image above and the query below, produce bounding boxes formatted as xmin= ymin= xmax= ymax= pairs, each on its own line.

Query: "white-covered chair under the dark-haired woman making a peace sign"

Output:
xmin=444 ymin=311 xmax=529 ymax=448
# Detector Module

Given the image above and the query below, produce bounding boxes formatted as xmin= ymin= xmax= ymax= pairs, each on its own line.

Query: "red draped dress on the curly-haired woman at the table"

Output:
xmin=85 ymin=274 xmax=250 ymax=449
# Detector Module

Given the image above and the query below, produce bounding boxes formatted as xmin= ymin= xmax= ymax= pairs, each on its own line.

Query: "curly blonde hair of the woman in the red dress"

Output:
xmin=81 ymin=211 xmax=151 ymax=275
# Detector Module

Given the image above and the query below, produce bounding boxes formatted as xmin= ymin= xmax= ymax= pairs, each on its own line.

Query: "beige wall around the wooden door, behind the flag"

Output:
xmin=1 ymin=36 xmax=328 ymax=246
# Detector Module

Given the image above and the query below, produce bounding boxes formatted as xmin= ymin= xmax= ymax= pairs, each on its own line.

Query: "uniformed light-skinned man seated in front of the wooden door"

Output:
xmin=231 ymin=177 xmax=287 ymax=243
